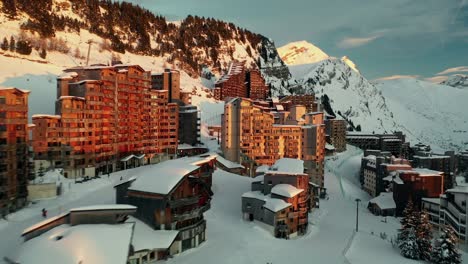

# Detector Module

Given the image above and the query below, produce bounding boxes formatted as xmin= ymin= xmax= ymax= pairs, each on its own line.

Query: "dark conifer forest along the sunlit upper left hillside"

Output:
xmin=0 ymin=0 xmax=264 ymax=74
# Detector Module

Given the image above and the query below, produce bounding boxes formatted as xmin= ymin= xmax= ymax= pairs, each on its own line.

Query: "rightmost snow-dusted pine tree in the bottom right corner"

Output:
xmin=431 ymin=226 xmax=461 ymax=264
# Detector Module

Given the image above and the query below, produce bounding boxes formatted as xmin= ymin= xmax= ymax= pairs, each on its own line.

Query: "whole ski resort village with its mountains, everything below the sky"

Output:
xmin=0 ymin=0 xmax=468 ymax=264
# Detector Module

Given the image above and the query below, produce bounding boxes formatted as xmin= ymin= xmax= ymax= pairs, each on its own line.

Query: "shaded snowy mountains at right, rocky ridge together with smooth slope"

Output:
xmin=290 ymin=40 xmax=468 ymax=150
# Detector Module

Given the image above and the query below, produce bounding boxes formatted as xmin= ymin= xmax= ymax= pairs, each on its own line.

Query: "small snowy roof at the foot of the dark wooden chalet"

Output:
xmin=127 ymin=216 xmax=179 ymax=251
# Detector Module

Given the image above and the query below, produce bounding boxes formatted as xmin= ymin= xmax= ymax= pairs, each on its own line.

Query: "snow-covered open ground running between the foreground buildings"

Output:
xmin=0 ymin=146 xmax=468 ymax=264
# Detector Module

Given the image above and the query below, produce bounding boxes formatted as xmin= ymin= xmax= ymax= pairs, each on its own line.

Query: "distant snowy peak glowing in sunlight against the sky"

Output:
xmin=278 ymin=40 xmax=329 ymax=65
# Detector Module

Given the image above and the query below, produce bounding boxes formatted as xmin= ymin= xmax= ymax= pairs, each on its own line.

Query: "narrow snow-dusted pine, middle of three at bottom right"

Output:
xmin=415 ymin=211 xmax=432 ymax=261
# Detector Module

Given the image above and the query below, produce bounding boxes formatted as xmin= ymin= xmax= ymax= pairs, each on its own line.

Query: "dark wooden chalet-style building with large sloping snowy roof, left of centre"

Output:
xmin=115 ymin=155 xmax=216 ymax=252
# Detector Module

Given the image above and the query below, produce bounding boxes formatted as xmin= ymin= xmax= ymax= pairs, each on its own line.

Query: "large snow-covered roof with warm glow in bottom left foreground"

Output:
xmin=16 ymin=223 xmax=133 ymax=264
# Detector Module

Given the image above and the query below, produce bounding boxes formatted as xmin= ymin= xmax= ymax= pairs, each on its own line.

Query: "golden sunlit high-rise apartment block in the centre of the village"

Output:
xmin=221 ymin=98 xmax=325 ymax=187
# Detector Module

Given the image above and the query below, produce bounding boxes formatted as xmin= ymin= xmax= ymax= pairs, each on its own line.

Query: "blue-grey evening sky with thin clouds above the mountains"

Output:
xmin=126 ymin=0 xmax=468 ymax=79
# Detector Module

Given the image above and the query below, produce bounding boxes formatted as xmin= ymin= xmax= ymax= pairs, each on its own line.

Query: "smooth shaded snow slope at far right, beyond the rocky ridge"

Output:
xmin=376 ymin=78 xmax=468 ymax=150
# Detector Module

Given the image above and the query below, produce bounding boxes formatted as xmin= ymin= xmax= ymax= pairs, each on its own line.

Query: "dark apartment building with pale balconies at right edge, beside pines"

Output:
xmin=422 ymin=185 xmax=468 ymax=244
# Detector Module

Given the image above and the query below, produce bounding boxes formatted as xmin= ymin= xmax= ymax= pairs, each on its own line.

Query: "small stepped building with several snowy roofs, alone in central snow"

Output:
xmin=242 ymin=158 xmax=311 ymax=238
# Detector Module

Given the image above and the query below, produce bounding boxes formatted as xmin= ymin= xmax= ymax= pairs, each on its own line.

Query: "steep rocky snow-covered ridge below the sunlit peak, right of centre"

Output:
xmin=290 ymin=58 xmax=396 ymax=132
